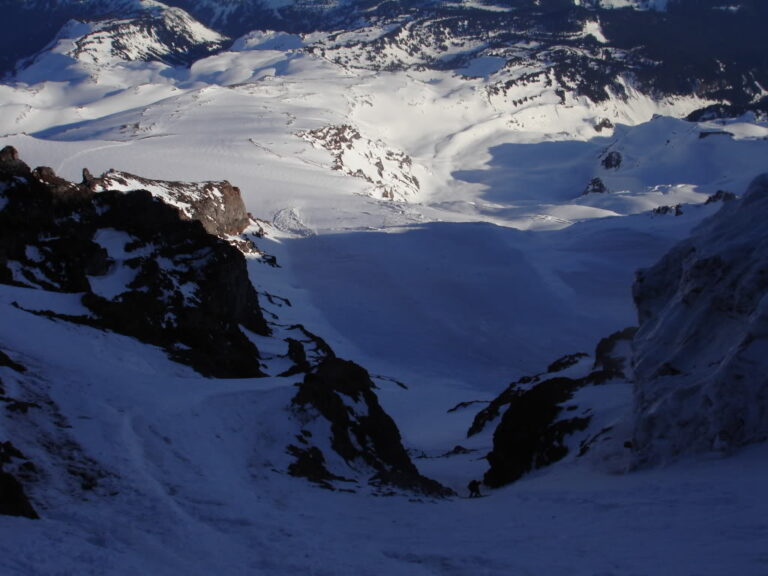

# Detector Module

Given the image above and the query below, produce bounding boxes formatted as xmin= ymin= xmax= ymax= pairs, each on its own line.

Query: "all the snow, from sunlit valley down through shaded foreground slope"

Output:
xmin=0 ymin=0 xmax=768 ymax=576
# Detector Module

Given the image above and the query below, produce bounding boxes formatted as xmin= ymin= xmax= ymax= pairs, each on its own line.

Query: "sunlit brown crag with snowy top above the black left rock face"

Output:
xmin=83 ymin=170 xmax=251 ymax=237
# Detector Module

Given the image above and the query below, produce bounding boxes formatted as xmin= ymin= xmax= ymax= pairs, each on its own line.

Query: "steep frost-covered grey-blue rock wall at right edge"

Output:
xmin=634 ymin=175 xmax=768 ymax=463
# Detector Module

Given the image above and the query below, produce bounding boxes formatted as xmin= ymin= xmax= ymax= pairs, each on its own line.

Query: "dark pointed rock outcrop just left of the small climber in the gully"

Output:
xmin=289 ymin=357 xmax=451 ymax=496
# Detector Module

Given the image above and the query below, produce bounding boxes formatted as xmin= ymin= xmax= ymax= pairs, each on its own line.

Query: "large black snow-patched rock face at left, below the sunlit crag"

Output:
xmin=0 ymin=149 xmax=269 ymax=377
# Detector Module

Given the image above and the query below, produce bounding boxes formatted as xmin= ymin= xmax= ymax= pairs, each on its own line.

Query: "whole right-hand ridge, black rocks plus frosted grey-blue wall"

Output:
xmin=468 ymin=175 xmax=768 ymax=487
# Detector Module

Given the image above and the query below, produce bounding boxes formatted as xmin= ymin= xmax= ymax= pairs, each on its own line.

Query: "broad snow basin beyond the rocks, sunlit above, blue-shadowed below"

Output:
xmin=0 ymin=23 xmax=768 ymax=396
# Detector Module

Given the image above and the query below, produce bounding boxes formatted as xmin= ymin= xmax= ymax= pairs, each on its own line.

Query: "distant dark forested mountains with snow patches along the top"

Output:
xmin=0 ymin=0 xmax=768 ymax=109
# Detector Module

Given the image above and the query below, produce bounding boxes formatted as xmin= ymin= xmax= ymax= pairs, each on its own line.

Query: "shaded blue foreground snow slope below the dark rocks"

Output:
xmin=0 ymin=288 xmax=768 ymax=576
